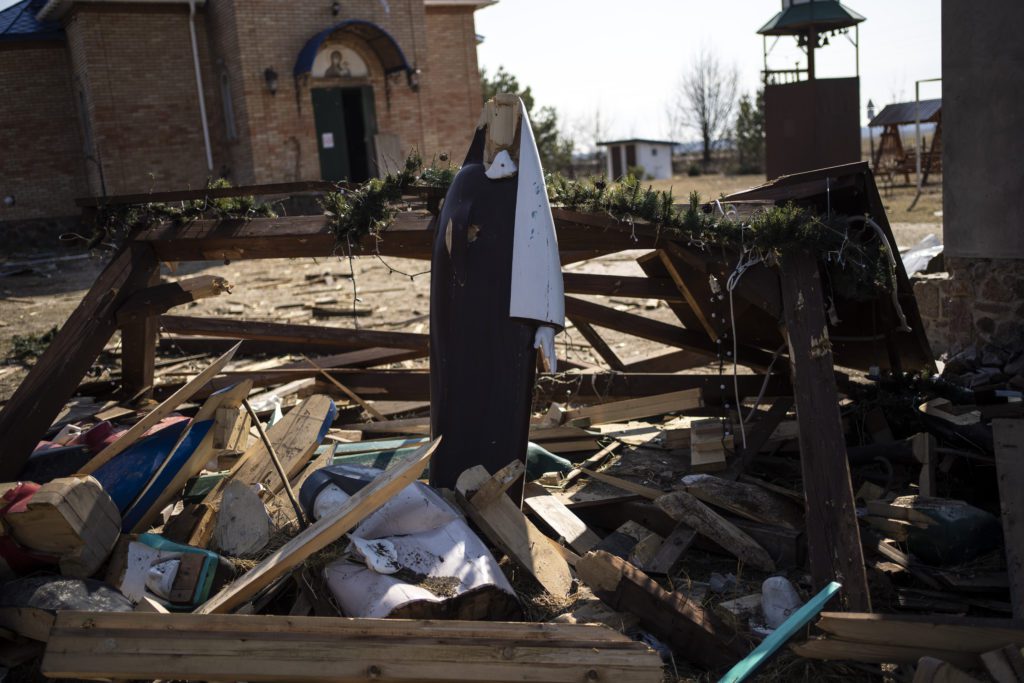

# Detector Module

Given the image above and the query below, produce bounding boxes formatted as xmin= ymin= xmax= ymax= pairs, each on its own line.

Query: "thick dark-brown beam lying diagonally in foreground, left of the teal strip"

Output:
xmin=577 ymin=551 xmax=746 ymax=669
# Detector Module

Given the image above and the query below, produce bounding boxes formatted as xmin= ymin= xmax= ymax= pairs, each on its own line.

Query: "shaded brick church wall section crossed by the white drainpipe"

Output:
xmin=66 ymin=3 xmax=225 ymax=195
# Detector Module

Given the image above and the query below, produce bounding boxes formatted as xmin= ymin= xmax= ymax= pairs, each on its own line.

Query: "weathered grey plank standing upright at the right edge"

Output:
xmin=992 ymin=419 xmax=1024 ymax=622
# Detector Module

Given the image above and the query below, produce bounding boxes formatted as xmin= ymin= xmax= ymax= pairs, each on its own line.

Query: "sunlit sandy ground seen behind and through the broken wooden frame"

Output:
xmin=0 ymin=175 xmax=942 ymax=401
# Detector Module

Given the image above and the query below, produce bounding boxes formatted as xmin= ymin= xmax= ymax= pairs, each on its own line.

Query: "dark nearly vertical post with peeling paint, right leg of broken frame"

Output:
xmin=780 ymin=249 xmax=871 ymax=611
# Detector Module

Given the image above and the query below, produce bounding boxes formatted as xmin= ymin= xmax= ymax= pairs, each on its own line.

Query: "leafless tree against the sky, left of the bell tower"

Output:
xmin=669 ymin=47 xmax=739 ymax=168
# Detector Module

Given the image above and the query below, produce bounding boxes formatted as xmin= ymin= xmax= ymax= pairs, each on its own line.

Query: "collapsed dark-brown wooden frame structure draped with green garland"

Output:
xmin=0 ymin=163 xmax=934 ymax=609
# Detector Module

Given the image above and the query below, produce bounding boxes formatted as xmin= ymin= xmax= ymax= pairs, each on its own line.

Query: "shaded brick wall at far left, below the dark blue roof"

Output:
xmin=0 ymin=43 xmax=86 ymax=222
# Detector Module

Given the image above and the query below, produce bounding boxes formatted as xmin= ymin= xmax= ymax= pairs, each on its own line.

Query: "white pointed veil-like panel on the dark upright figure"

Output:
xmin=509 ymin=99 xmax=565 ymax=331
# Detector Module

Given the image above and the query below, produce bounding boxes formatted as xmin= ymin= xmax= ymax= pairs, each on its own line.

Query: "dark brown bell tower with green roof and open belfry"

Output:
xmin=758 ymin=0 xmax=864 ymax=178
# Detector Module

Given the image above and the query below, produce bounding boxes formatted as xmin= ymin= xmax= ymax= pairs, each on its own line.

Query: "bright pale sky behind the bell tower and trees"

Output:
xmin=476 ymin=0 xmax=942 ymax=145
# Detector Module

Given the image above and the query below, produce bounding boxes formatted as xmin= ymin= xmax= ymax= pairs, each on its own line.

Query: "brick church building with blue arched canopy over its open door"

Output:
xmin=0 ymin=0 xmax=493 ymax=224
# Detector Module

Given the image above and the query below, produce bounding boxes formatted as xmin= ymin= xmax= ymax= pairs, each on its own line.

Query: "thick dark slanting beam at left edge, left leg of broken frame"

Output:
xmin=0 ymin=246 xmax=158 ymax=481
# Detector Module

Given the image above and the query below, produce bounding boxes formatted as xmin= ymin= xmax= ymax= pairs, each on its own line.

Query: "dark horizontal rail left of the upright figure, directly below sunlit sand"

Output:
xmin=160 ymin=315 xmax=429 ymax=350
